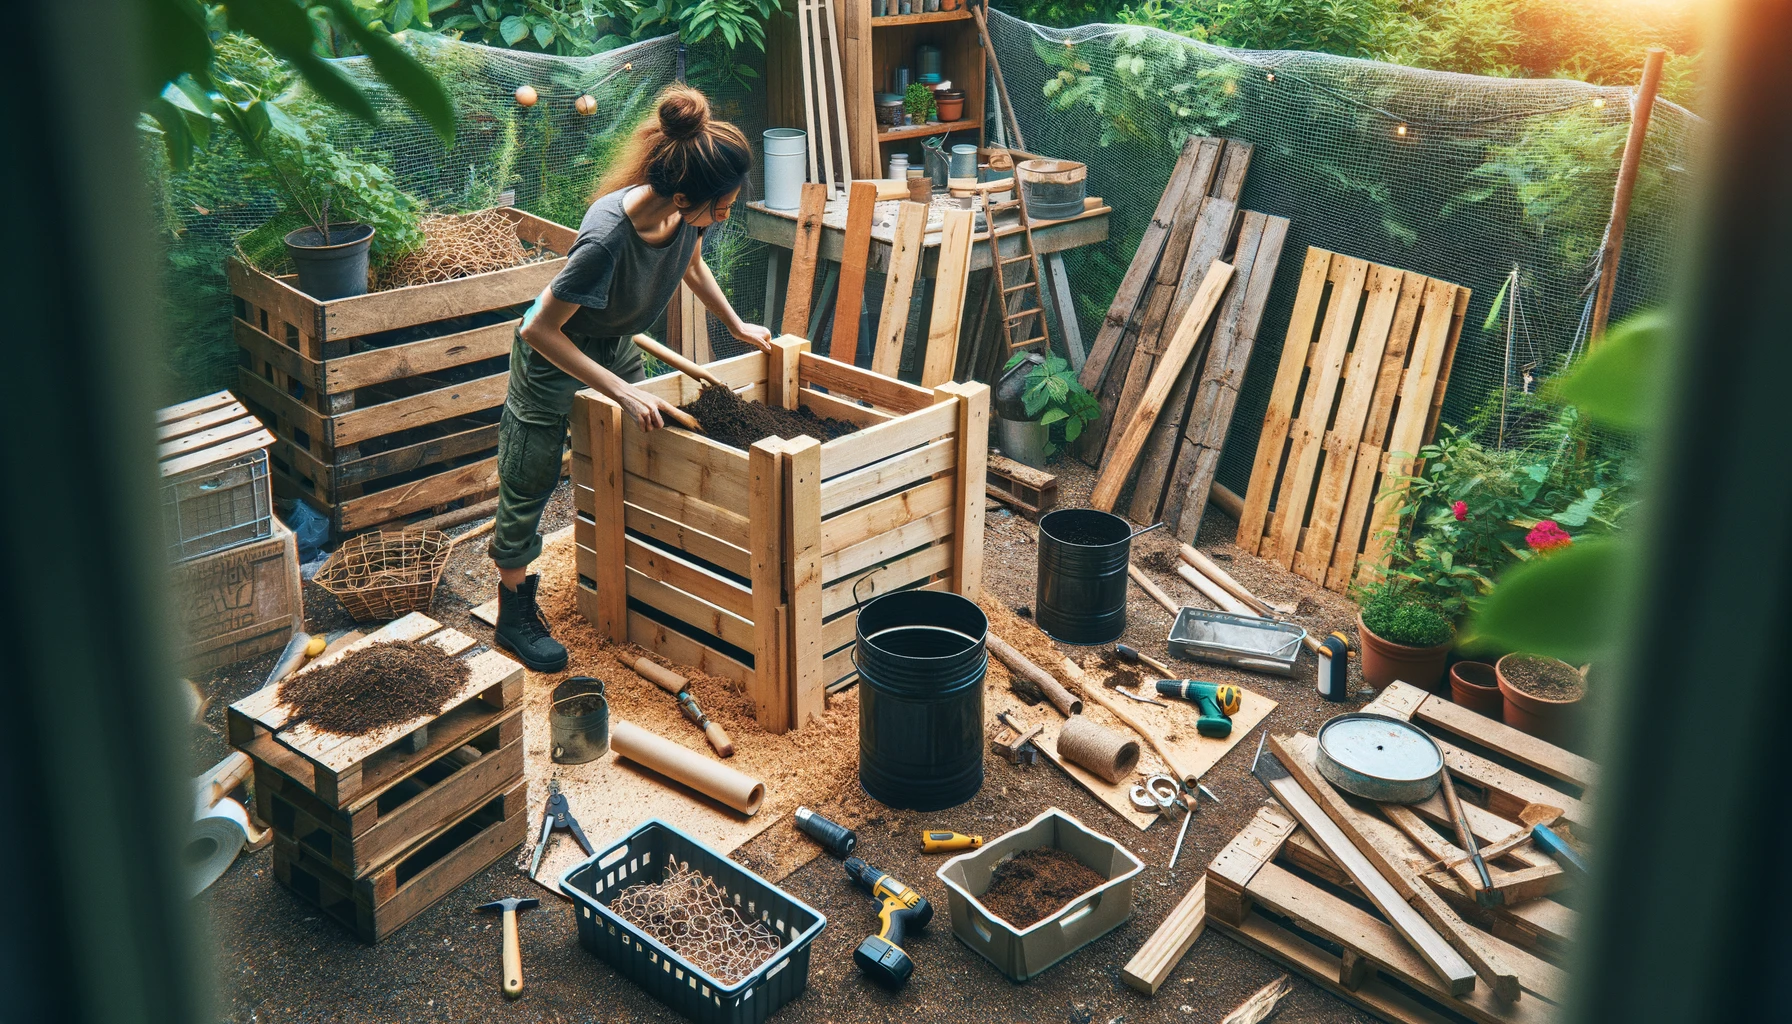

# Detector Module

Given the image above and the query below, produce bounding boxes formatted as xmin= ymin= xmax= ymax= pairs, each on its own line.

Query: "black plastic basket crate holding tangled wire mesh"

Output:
xmin=561 ymin=820 xmax=828 ymax=1024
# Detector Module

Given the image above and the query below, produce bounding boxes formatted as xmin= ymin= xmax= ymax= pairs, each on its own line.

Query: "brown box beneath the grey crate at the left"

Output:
xmin=170 ymin=520 xmax=305 ymax=674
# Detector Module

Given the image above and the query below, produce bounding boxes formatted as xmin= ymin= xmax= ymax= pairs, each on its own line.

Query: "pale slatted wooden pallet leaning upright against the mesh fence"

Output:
xmin=1238 ymin=247 xmax=1469 ymax=592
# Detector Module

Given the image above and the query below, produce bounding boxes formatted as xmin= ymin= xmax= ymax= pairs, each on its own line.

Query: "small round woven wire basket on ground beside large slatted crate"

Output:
xmin=315 ymin=529 xmax=453 ymax=622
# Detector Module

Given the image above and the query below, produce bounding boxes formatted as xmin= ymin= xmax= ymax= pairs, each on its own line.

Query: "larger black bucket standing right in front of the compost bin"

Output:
xmin=853 ymin=590 xmax=989 ymax=811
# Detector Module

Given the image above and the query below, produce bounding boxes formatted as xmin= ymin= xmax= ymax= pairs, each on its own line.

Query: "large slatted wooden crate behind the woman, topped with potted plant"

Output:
xmin=228 ymin=208 xmax=577 ymax=534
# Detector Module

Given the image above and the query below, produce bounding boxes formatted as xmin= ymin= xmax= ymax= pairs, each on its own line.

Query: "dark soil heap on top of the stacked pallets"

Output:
xmin=280 ymin=640 xmax=468 ymax=735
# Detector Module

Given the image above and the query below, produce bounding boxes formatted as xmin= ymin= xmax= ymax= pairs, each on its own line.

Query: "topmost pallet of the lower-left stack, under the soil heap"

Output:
xmin=226 ymin=612 xmax=523 ymax=809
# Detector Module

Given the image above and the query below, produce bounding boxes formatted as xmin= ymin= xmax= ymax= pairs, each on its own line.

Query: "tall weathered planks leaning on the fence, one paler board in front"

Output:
xmin=1077 ymin=138 xmax=1288 ymax=540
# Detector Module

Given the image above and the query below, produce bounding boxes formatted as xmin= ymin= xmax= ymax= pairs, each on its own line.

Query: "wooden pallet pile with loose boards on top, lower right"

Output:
xmin=1206 ymin=683 xmax=1595 ymax=1024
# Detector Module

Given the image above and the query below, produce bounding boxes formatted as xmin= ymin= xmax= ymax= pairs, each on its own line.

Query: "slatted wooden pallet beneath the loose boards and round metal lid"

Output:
xmin=1206 ymin=683 xmax=1595 ymax=1024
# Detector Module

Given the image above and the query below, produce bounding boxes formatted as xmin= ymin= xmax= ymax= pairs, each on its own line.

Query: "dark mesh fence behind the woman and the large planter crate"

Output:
xmin=145 ymin=36 xmax=765 ymax=402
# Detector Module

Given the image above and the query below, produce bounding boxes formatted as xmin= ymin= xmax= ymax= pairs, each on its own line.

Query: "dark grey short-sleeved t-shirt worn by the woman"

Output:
xmin=548 ymin=188 xmax=699 ymax=337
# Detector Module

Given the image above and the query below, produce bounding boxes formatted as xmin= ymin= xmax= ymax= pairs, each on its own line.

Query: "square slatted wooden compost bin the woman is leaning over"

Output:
xmin=572 ymin=335 xmax=989 ymax=732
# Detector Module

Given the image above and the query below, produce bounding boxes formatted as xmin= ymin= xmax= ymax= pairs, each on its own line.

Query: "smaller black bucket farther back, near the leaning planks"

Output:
xmin=1032 ymin=509 xmax=1133 ymax=646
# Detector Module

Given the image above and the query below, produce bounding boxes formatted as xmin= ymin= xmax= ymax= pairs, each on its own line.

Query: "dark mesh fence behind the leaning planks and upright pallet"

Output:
xmin=987 ymin=11 xmax=1702 ymax=493
